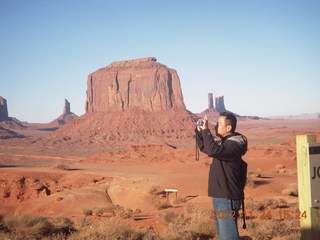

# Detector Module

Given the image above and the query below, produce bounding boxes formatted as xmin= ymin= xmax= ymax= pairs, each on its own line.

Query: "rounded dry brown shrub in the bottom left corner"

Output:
xmin=5 ymin=214 xmax=55 ymax=240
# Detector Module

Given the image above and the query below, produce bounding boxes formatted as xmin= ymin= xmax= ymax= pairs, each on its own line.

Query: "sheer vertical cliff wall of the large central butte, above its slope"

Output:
xmin=86 ymin=58 xmax=185 ymax=112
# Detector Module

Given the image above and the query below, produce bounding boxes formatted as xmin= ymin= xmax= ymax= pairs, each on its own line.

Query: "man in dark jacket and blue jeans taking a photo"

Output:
xmin=196 ymin=112 xmax=247 ymax=240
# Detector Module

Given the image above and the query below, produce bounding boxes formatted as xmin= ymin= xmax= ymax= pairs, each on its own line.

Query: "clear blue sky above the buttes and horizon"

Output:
xmin=0 ymin=0 xmax=320 ymax=123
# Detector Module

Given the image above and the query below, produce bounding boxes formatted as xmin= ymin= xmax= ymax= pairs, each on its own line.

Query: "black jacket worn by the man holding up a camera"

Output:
xmin=196 ymin=129 xmax=247 ymax=199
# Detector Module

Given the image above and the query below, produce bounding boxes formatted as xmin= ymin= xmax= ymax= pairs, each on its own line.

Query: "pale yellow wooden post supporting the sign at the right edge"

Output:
xmin=296 ymin=135 xmax=320 ymax=240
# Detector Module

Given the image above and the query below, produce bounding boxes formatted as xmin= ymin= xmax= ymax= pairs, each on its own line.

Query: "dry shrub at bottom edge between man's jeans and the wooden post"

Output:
xmin=248 ymin=219 xmax=299 ymax=240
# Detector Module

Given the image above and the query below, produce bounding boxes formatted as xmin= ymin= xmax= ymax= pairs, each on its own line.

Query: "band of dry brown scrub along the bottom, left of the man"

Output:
xmin=0 ymin=205 xmax=215 ymax=240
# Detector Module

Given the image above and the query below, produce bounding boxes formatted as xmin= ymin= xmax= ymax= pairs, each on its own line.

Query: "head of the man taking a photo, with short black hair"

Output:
xmin=216 ymin=112 xmax=237 ymax=137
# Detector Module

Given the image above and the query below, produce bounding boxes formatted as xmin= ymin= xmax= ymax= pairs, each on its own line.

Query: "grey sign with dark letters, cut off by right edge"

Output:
xmin=308 ymin=143 xmax=320 ymax=207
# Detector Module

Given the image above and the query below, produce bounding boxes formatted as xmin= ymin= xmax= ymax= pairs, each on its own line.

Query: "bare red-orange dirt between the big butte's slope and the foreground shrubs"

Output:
xmin=0 ymin=119 xmax=320 ymax=237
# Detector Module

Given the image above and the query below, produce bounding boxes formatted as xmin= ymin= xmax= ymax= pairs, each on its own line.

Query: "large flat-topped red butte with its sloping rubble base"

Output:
xmin=43 ymin=57 xmax=196 ymax=146
